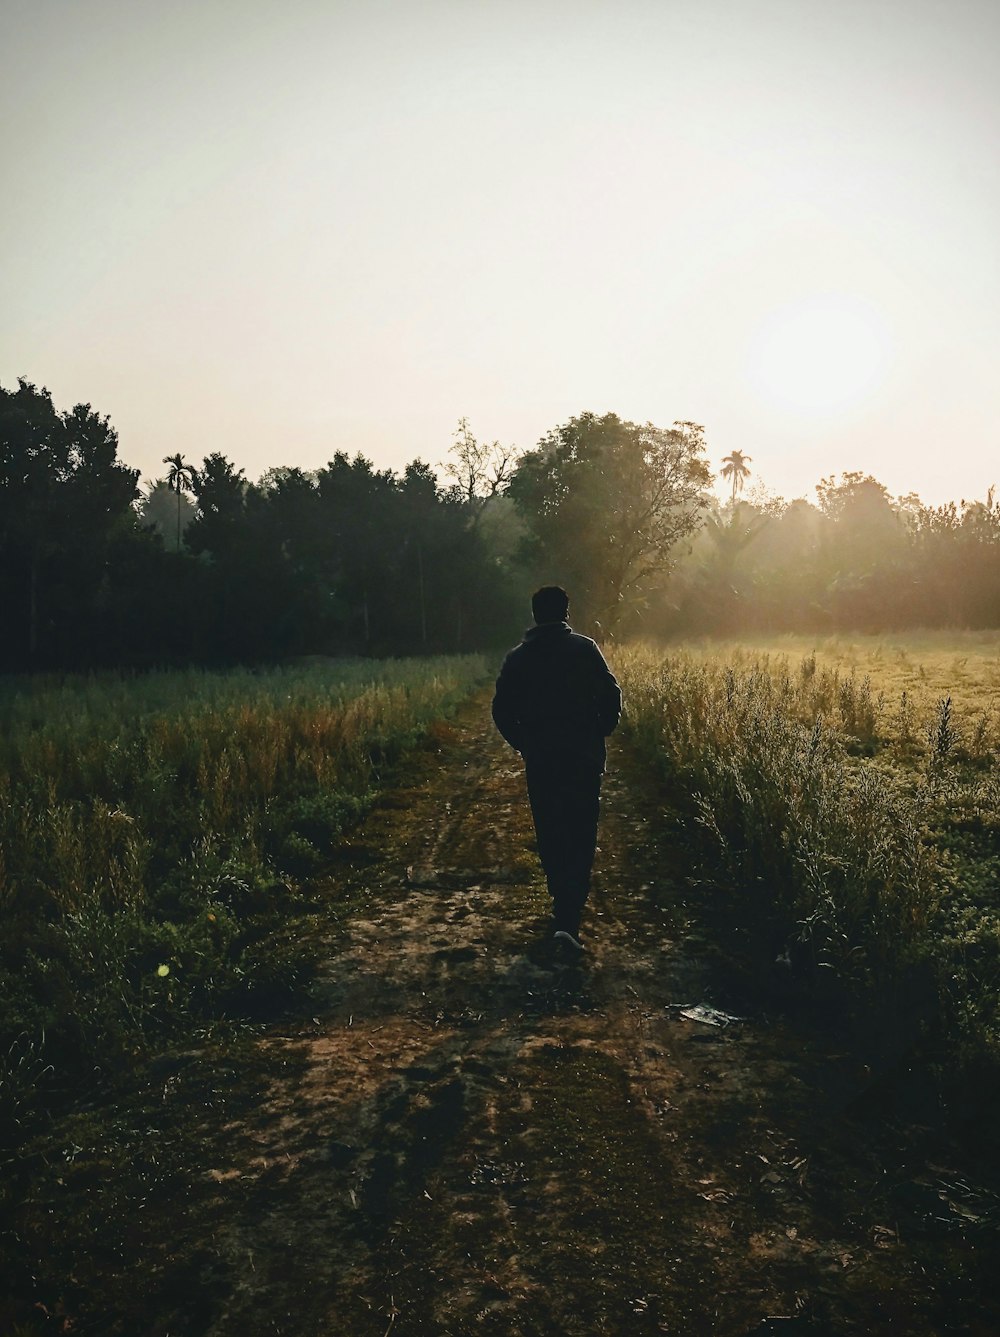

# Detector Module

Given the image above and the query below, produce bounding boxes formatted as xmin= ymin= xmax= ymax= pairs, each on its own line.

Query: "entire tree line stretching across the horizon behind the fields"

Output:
xmin=0 ymin=380 xmax=1000 ymax=671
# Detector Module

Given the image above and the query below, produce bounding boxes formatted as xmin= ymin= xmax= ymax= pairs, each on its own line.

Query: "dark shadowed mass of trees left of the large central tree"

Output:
xmin=0 ymin=381 xmax=524 ymax=670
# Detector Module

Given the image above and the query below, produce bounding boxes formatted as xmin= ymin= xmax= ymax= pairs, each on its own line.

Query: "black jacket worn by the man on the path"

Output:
xmin=493 ymin=622 xmax=622 ymax=770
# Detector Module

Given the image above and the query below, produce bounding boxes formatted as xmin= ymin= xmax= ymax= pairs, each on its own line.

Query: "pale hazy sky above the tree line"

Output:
xmin=0 ymin=0 xmax=1000 ymax=504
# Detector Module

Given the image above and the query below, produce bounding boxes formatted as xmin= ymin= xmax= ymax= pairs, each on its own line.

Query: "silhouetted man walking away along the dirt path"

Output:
xmin=493 ymin=586 xmax=622 ymax=952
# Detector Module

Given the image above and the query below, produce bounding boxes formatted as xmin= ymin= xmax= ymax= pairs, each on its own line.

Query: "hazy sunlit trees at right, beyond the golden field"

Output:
xmin=655 ymin=473 xmax=1000 ymax=634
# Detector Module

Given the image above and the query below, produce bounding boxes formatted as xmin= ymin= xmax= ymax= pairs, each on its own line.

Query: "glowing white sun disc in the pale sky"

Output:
xmin=747 ymin=293 xmax=892 ymax=417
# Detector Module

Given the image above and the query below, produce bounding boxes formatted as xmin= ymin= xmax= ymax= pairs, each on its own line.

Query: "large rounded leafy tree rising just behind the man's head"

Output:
xmin=511 ymin=413 xmax=711 ymax=631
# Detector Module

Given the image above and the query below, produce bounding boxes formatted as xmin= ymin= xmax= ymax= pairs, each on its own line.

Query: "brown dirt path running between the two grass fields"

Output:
xmin=7 ymin=697 xmax=1000 ymax=1337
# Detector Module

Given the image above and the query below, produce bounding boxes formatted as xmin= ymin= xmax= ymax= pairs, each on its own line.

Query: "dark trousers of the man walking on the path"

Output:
xmin=524 ymin=757 xmax=600 ymax=933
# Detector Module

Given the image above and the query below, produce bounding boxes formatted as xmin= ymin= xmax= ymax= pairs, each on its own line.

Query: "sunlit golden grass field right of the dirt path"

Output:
xmin=615 ymin=634 xmax=1000 ymax=1071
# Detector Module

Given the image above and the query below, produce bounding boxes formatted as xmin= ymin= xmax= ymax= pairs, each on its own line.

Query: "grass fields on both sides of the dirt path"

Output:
xmin=0 ymin=634 xmax=1000 ymax=1146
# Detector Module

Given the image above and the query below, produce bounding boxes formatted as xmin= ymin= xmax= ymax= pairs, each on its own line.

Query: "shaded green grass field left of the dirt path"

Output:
xmin=0 ymin=656 xmax=485 ymax=1146
